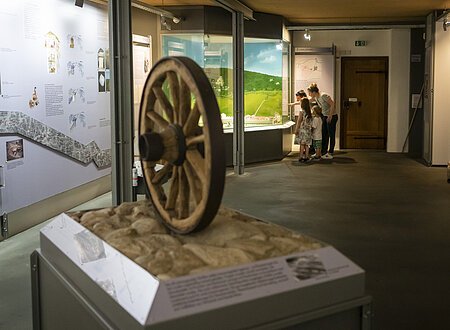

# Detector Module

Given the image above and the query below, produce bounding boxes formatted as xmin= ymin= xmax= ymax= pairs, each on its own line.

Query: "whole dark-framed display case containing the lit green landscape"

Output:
xmin=156 ymin=6 xmax=295 ymax=166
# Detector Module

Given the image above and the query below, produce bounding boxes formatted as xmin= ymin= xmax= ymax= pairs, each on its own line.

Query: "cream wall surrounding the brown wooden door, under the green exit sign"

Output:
xmin=293 ymin=29 xmax=410 ymax=152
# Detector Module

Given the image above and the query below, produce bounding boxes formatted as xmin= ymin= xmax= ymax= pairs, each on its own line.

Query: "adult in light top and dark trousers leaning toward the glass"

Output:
xmin=308 ymin=83 xmax=338 ymax=159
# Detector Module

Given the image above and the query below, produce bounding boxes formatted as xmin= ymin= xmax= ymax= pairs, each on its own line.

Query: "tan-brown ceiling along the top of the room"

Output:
xmin=140 ymin=0 xmax=450 ymax=25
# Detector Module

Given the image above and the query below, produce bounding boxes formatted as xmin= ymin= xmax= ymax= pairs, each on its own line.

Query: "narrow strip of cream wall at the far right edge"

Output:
xmin=431 ymin=22 xmax=450 ymax=165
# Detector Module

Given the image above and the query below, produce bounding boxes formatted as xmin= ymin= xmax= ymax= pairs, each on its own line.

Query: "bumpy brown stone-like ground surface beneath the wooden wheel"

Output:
xmin=69 ymin=200 xmax=325 ymax=280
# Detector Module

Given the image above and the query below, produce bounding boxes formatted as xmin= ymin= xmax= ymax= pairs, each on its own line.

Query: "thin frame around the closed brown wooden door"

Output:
xmin=339 ymin=56 xmax=389 ymax=150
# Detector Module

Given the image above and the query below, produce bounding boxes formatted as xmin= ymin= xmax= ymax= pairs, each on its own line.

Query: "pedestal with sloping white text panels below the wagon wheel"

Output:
xmin=31 ymin=214 xmax=371 ymax=330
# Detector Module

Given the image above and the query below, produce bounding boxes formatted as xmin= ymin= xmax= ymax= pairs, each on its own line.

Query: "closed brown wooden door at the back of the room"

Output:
xmin=341 ymin=57 xmax=388 ymax=149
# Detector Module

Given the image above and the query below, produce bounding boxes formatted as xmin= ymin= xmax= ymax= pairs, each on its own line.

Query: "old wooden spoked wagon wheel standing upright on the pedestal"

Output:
xmin=139 ymin=57 xmax=225 ymax=234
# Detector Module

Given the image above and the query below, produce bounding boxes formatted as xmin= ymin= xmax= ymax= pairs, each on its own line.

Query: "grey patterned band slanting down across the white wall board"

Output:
xmin=0 ymin=111 xmax=111 ymax=168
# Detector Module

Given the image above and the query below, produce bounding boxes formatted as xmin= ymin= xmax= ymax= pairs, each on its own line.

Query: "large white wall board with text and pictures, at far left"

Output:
xmin=0 ymin=0 xmax=111 ymax=212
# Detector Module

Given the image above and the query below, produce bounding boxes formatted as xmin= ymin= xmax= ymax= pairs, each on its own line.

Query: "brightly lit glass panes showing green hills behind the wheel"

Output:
xmin=162 ymin=33 xmax=290 ymax=129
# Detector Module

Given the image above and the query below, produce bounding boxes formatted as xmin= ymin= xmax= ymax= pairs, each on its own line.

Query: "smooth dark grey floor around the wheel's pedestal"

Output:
xmin=0 ymin=151 xmax=450 ymax=330
